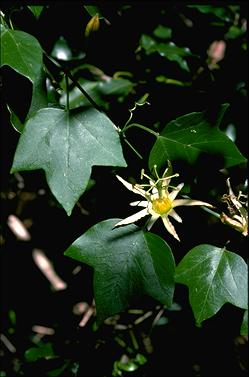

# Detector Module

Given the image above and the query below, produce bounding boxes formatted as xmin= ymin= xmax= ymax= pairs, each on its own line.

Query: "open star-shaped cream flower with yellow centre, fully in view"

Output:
xmin=115 ymin=161 xmax=213 ymax=241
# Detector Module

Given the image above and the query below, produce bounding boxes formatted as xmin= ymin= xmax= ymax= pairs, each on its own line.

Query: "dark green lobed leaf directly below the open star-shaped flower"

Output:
xmin=64 ymin=219 xmax=175 ymax=324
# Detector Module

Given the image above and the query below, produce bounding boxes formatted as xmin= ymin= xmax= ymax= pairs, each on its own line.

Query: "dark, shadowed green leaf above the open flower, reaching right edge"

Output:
xmin=149 ymin=104 xmax=246 ymax=169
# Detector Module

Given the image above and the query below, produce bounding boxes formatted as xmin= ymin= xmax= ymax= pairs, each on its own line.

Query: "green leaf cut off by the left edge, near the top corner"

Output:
xmin=0 ymin=25 xmax=42 ymax=82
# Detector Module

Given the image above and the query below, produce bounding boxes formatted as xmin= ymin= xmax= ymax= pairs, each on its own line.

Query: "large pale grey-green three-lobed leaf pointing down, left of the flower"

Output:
xmin=11 ymin=108 xmax=126 ymax=215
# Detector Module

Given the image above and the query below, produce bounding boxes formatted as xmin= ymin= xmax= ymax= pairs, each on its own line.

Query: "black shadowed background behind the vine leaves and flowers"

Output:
xmin=0 ymin=2 xmax=248 ymax=376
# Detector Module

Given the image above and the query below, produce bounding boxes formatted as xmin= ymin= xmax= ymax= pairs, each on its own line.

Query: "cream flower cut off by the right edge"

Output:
xmin=220 ymin=178 xmax=248 ymax=236
